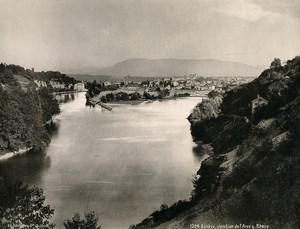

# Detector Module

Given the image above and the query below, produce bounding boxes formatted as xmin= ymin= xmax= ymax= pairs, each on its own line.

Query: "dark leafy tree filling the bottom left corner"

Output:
xmin=0 ymin=182 xmax=55 ymax=229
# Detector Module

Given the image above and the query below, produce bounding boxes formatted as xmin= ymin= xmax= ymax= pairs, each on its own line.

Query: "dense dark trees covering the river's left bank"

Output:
xmin=0 ymin=64 xmax=60 ymax=154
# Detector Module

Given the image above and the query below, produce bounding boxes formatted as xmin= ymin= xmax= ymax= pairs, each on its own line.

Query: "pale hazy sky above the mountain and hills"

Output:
xmin=0 ymin=0 xmax=300 ymax=72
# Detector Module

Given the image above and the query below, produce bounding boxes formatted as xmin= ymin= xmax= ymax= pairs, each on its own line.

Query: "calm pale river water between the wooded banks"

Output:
xmin=0 ymin=93 xmax=203 ymax=229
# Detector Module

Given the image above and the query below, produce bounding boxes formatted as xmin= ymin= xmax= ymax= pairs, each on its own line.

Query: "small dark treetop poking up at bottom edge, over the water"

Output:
xmin=64 ymin=211 xmax=101 ymax=229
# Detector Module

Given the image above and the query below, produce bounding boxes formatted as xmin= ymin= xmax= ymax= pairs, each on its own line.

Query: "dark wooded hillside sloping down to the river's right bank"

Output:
xmin=132 ymin=56 xmax=300 ymax=229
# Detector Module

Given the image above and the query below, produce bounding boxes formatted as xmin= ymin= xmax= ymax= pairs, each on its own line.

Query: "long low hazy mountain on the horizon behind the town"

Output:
xmin=69 ymin=58 xmax=264 ymax=77
